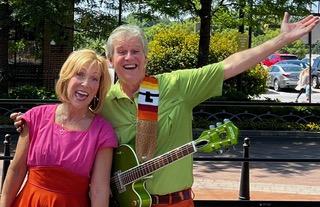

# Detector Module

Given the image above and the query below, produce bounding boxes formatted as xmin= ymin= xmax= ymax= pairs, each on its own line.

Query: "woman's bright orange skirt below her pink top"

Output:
xmin=13 ymin=167 xmax=90 ymax=207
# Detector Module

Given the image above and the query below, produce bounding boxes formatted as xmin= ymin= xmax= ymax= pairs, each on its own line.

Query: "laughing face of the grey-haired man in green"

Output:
xmin=111 ymin=37 xmax=146 ymax=85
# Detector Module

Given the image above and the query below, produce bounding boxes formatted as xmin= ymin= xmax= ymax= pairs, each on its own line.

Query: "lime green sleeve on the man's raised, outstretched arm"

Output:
xmin=161 ymin=62 xmax=224 ymax=108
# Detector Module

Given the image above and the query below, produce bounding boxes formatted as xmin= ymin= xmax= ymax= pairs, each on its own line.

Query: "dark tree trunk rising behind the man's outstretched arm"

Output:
xmin=198 ymin=0 xmax=212 ymax=67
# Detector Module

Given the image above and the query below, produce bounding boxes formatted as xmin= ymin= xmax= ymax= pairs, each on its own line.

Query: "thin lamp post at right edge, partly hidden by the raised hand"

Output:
xmin=308 ymin=1 xmax=320 ymax=103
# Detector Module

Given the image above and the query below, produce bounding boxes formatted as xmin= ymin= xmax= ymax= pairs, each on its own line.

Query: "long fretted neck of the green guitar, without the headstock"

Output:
xmin=119 ymin=142 xmax=197 ymax=185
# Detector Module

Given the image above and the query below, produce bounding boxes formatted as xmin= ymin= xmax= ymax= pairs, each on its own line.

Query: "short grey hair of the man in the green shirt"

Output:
xmin=105 ymin=24 xmax=148 ymax=60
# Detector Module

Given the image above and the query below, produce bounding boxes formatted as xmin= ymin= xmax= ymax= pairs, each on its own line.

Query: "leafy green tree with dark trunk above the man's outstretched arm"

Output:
xmin=136 ymin=0 xmax=312 ymax=66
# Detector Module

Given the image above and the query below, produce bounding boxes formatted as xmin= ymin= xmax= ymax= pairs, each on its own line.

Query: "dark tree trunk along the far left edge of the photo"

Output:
xmin=0 ymin=1 xmax=9 ymax=94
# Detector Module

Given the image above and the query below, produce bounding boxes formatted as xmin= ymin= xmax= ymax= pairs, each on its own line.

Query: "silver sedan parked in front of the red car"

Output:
xmin=266 ymin=64 xmax=302 ymax=91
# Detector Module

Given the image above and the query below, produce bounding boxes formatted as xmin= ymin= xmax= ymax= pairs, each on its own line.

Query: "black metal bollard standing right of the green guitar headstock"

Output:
xmin=239 ymin=137 xmax=250 ymax=200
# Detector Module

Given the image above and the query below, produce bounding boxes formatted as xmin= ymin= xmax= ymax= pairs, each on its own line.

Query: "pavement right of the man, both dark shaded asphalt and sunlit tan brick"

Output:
xmin=193 ymin=138 xmax=320 ymax=201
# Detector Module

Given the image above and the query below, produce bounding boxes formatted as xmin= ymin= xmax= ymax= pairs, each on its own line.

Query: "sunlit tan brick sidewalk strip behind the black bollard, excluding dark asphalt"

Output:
xmin=193 ymin=163 xmax=320 ymax=201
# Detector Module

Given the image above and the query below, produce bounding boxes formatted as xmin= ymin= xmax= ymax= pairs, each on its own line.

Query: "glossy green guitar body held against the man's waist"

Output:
xmin=110 ymin=145 xmax=152 ymax=207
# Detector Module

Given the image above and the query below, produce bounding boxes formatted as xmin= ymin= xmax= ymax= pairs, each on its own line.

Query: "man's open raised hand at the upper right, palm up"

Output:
xmin=281 ymin=12 xmax=319 ymax=42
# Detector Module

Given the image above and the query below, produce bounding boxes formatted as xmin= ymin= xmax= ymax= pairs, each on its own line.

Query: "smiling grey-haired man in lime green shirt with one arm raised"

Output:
xmin=12 ymin=13 xmax=319 ymax=207
